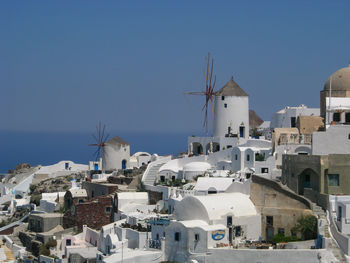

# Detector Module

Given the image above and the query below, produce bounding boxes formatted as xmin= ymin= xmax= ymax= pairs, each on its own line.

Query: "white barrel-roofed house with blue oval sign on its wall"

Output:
xmin=165 ymin=193 xmax=261 ymax=262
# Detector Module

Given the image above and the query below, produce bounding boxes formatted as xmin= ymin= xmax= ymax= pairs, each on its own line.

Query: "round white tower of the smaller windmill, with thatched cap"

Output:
xmin=102 ymin=136 xmax=130 ymax=171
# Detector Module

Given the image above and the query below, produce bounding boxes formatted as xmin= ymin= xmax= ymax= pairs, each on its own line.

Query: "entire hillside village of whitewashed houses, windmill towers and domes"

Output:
xmin=0 ymin=64 xmax=350 ymax=263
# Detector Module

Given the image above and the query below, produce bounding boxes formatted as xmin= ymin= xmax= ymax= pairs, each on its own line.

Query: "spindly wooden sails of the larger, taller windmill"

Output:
xmin=185 ymin=53 xmax=216 ymax=135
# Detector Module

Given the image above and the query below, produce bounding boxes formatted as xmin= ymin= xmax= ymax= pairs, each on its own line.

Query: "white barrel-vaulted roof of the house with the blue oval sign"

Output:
xmin=175 ymin=193 xmax=258 ymax=224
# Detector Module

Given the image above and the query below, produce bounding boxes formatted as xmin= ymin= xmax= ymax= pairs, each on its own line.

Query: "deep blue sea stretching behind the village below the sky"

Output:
xmin=0 ymin=131 xmax=196 ymax=174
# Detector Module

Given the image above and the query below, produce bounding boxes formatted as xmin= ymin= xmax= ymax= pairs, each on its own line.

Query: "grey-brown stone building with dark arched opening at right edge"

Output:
xmin=282 ymin=154 xmax=350 ymax=209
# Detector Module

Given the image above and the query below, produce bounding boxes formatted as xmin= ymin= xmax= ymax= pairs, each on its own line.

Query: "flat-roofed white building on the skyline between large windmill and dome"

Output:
xmin=270 ymin=104 xmax=320 ymax=129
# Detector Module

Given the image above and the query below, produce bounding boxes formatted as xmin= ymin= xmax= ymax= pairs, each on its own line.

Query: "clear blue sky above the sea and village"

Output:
xmin=0 ymin=0 xmax=350 ymax=133
